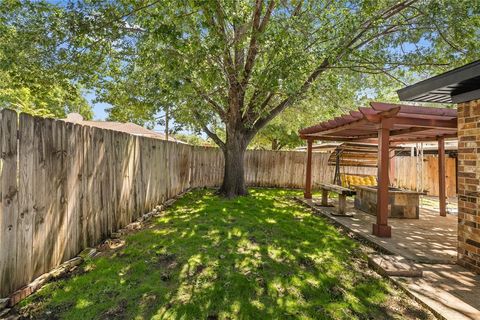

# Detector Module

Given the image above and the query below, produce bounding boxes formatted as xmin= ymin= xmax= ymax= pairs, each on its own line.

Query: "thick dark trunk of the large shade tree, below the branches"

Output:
xmin=218 ymin=132 xmax=249 ymax=198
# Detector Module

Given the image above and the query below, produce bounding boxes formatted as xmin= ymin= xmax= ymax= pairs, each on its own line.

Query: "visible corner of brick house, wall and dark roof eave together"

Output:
xmin=398 ymin=60 xmax=480 ymax=273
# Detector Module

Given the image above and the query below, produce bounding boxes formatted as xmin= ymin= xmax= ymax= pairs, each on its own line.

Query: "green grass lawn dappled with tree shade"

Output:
xmin=16 ymin=189 xmax=430 ymax=320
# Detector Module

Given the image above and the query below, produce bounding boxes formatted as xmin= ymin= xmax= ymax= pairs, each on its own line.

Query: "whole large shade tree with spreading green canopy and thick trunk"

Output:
xmin=62 ymin=0 xmax=479 ymax=197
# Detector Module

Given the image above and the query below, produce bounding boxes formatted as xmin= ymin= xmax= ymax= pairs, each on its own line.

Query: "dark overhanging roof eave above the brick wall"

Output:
xmin=397 ymin=60 xmax=480 ymax=103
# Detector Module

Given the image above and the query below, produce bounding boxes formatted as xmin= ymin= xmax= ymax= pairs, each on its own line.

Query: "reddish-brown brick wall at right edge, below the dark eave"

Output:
xmin=458 ymin=100 xmax=480 ymax=273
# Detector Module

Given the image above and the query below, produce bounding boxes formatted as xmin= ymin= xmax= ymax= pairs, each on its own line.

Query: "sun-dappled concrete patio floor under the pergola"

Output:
xmin=299 ymin=197 xmax=480 ymax=320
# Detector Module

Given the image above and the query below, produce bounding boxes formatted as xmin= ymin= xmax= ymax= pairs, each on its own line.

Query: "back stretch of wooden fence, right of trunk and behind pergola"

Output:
xmin=245 ymin=150 xmax=456 ymax=197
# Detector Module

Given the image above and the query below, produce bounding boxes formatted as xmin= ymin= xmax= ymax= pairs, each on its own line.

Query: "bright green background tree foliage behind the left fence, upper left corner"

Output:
xmin=0 ymin=1 xmax=92 ymax=118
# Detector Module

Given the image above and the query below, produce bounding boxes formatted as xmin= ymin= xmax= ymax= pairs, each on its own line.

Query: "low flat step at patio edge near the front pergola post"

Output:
xmin=368 ymin=254 xmax=423 ymax=277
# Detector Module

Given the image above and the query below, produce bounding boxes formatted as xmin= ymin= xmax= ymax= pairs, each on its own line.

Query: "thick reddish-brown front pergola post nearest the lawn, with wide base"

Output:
xmin=373 ymin=119 xmax=392 ymax=238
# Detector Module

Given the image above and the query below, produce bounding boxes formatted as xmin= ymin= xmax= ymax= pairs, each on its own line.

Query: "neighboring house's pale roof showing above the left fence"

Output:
xmin=65 ymin=113 xmax=186 ymax=143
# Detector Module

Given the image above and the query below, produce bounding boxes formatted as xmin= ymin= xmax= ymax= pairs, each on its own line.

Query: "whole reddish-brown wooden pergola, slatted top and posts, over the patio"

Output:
xmin=299 ymin=102 xmax=457 ymax=237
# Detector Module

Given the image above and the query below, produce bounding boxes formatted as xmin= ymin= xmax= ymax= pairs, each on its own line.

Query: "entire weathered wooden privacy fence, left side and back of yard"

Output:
xmin=0 ymin=110 xmax=454 ymax=297
